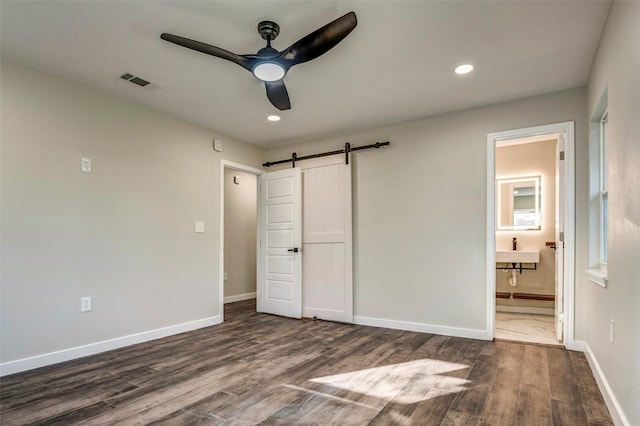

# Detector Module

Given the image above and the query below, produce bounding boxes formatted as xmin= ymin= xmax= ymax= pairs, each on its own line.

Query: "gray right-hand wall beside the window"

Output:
xmin=580 ymin=1 xmax=640 ymax=425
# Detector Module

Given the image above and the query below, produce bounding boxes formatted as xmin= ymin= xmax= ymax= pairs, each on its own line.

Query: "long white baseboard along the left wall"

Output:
xmin=0 ymin=315 xmax=222 ymax=377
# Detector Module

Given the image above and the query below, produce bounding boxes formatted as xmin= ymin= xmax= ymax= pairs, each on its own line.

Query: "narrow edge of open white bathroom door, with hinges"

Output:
xmin=555 ymin=135 xmax=565 ymax=341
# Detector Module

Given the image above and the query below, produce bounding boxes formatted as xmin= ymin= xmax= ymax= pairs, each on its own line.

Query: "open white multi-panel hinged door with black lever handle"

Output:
xmin=257 ymin=168 xmax=302 ymax=318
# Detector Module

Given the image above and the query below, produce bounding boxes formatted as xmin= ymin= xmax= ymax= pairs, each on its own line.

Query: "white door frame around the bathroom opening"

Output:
xmin=486 ymin=121 xmax=581 ymax=350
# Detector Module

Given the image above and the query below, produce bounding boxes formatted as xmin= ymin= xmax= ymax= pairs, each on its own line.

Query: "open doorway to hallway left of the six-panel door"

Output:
xmin=220 ymin=160 xmax=263 ymax=320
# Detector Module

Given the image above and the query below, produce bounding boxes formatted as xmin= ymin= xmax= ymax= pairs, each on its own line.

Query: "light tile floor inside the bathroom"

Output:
xmin=495 ymin=312 xmax=562 ymax=346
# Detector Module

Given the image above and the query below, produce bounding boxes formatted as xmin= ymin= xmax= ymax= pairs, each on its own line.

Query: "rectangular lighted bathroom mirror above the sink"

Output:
xmin=496 ymin=176 xmax=542 ymax=231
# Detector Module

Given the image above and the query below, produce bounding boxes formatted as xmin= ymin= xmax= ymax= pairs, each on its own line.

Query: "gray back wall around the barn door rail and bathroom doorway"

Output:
xmin=267 ymin=88 xmax=588 ymax=340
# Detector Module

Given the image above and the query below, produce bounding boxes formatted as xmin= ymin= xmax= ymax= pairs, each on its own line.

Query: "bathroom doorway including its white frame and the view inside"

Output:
xmin=487 ymin=123 xmax=573 ymax=346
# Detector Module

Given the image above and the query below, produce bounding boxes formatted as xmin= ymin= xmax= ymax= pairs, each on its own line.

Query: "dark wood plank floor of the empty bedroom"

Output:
xmin=0 ymin=301 xmax=612 ymax=425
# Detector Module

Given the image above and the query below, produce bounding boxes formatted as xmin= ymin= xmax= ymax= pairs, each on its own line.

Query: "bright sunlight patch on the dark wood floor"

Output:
xmin=310 ymin=359 xmax=469 ymax=404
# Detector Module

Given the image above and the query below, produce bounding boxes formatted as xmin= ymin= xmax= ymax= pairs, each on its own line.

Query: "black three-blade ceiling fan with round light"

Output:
xmin=160 ymin=12 xmax=358 ymax=110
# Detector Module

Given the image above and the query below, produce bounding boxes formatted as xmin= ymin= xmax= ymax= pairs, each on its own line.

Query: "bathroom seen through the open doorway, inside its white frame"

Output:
xmin=495 ymin=134 xmax=562 ymax=345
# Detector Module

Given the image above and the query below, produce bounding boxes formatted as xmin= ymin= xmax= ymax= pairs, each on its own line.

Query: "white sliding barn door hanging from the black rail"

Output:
xmin=300 ymin=155 xmax=353 ymax=322
